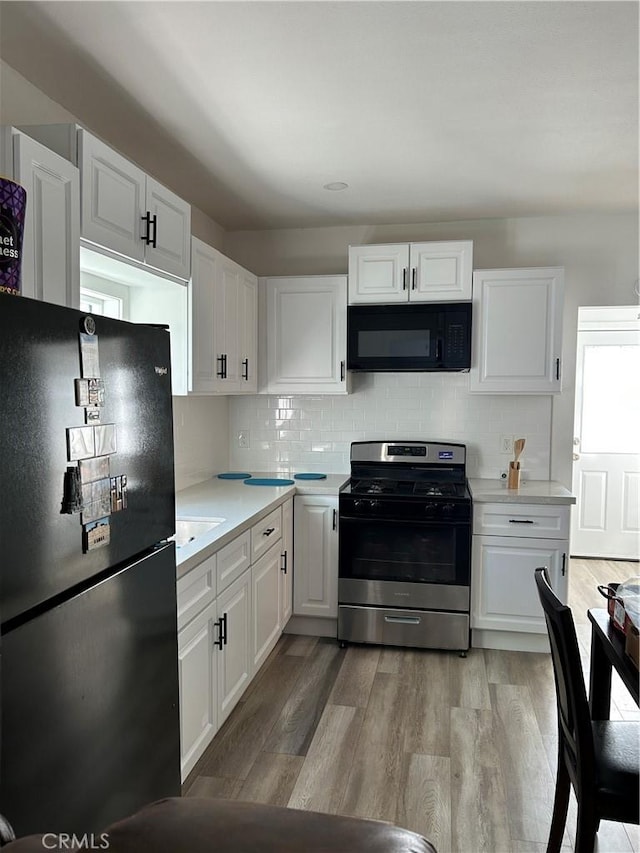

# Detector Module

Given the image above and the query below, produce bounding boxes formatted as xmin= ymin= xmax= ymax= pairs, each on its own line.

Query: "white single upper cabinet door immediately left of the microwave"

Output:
xmin=265 ymin=276 xmax=347 ymax=394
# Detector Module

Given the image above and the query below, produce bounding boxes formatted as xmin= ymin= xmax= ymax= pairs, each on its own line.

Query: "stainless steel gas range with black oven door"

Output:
xmin=338 ymin=441 xmax=471 ymax=652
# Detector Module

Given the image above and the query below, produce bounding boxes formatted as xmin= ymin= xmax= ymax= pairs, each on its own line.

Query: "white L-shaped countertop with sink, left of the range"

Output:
xmin=176 ymin=471 xmax=349 ymax=577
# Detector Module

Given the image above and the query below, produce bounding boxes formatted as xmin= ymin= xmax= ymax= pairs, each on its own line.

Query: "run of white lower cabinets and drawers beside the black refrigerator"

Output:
xmin=178 ymin=498 xmax=293 ymax=781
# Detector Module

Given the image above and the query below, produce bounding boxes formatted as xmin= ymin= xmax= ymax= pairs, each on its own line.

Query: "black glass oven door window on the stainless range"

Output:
xmin=340 ymin=518 xmax=470 ymax=586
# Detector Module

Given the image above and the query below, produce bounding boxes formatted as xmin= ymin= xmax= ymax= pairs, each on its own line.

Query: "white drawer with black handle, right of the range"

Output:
xmin=473 ymin=503 xmax=570 ymax=539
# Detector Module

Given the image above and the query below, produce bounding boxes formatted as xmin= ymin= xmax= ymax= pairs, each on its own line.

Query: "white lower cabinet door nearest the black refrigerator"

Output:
xmin=178 ymin=601 xmax=218 ymax=781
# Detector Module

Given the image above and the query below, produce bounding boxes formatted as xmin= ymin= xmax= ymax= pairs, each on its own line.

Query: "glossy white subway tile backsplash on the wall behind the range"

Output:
xmin=229 ymin=373 xmax=551 ymax=479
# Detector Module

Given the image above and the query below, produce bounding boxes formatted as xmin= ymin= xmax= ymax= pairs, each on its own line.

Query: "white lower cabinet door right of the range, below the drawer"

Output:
xmin=471 ymin=536 xmax=569 ymax=634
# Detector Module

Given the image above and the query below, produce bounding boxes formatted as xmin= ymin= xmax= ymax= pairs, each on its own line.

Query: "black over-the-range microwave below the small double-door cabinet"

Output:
xmin=347 ymin=302 xmax=471 ymax=371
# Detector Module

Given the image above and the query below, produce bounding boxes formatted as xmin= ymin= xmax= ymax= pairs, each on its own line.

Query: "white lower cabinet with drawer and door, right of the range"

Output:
xmin=471 ymin=496 xmax=569 ymax=651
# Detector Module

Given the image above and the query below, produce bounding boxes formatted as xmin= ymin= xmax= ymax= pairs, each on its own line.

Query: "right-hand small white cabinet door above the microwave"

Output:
xmin=409 ymin=240 xmax=473 ymax=302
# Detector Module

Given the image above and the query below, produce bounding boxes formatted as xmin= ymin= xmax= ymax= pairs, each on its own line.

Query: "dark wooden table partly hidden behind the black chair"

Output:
xmin=587 ymin=608 xmax=640 ymax=720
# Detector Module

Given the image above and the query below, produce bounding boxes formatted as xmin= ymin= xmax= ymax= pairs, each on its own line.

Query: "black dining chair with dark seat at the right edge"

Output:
xmin=535 ymin=568 xmax=640 ymax=853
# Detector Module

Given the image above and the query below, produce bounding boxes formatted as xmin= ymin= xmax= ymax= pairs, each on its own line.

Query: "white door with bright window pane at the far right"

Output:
xmin=571 ymin=309 xmax=640 ymax=559
